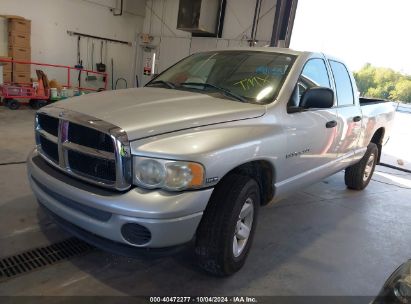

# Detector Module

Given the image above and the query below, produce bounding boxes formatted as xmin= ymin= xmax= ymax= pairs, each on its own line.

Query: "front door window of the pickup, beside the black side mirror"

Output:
xmin=288 ymin=58 xmax=331 ymax=108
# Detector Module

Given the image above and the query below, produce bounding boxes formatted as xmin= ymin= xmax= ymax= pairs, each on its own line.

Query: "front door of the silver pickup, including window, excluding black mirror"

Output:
xmin=285 ymin=58 xmax=337 ymax=182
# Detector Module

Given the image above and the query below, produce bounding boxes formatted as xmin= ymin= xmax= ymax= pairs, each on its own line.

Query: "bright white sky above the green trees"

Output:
xmin=290 ymin=0 xmax=411 ymax=75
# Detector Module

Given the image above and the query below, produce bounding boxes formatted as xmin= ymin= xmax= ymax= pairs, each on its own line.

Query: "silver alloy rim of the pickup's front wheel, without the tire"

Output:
xmin=233 ymin=198 xmax=254 ymax=257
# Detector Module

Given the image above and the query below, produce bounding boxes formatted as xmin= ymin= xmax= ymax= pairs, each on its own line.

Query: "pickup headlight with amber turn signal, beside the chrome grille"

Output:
xmin=133 ymin=157 xmax=204 ymax=191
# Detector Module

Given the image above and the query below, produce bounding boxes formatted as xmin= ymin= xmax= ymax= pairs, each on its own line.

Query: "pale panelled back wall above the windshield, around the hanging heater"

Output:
xmin=144 ymin=0 xmax=276 ymax=72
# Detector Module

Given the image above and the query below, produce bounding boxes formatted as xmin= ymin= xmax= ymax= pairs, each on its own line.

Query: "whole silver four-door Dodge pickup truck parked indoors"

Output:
xmin=28 ymin=48 xmax=394 ymax=275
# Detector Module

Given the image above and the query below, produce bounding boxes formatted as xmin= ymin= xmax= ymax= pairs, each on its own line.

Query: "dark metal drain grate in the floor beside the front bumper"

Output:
xmin=0 ymin=238 xmax=95 ymax=281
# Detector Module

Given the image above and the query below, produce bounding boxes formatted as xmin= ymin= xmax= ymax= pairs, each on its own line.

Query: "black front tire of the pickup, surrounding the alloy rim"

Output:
xmin=195 ymin=174 xmax=260 ymax=276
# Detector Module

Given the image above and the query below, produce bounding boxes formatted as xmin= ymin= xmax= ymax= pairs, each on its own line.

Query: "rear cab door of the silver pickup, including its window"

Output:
xmin=329 ymin=60 xmax=362 ymax=162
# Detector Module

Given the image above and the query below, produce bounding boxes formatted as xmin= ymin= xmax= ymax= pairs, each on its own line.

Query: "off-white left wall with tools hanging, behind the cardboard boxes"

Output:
xmin=0 ymin=0 xmax=145 ymax=87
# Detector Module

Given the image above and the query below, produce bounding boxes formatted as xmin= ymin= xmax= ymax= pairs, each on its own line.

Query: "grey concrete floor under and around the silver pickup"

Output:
xmin=0 ymin=107 xmax=411 ymax=296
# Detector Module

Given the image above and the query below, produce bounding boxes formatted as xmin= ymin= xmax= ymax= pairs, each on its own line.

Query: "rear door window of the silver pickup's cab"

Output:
xmin=330 ymin=60 xmax=354 ymax=106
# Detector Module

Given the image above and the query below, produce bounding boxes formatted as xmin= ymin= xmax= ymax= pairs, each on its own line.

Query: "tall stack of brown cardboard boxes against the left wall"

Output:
xmin=8 ymin=18 xmax=31 ymax=83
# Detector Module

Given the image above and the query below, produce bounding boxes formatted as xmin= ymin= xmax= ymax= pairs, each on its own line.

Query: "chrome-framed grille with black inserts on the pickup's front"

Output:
xmin=36 ymin=107 xmax=131 ymax=191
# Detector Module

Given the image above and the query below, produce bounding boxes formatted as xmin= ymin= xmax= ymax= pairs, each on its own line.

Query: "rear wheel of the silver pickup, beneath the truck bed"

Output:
xmin=344 ymin=143 xmax=379 ymax=190
